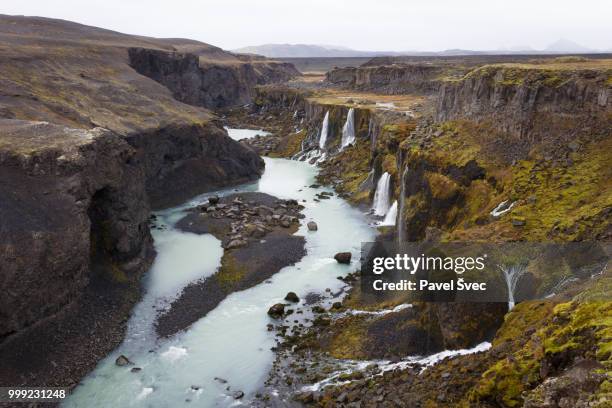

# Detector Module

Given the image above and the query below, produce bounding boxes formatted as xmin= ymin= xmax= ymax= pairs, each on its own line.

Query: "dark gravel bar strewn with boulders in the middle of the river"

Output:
xmin=156 ymin=193 xmax=306 ymax=337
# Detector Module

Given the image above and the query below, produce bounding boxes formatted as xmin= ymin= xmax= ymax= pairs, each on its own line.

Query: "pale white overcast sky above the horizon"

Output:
xmin=0 ymin=0 xmax=612 ymax=51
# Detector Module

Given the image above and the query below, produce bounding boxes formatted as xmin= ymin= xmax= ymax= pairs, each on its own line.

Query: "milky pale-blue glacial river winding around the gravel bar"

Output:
xmin=63 ymin=129 xmax=375 ymax=408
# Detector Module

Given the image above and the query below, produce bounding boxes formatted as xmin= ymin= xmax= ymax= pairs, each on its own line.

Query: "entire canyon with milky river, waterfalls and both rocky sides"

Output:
xmin=0 ymin=12 xmax=612 ymax=407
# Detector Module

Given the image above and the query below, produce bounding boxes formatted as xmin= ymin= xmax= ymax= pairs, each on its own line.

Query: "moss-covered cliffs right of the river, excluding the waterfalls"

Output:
xmin=225 ymin=58 xmax=612 ymax=407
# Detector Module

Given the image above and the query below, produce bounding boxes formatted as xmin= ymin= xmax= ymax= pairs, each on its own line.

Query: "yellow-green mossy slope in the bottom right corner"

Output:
xmin=469 ymin=284 xmax=612 ymax=407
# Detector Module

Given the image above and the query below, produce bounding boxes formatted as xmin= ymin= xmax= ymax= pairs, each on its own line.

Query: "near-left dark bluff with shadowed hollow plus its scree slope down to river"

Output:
xmin=0 ymin=120 xmax=153 ymax=386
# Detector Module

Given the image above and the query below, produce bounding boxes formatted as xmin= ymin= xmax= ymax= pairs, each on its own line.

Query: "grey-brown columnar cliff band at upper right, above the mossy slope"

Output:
xmin=436 ymin=66 xmax=612 ymax=141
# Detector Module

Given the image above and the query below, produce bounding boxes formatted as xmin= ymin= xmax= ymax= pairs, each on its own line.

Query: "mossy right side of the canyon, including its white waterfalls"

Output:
xmin=227 ymin=57 xmax=612 ymax=406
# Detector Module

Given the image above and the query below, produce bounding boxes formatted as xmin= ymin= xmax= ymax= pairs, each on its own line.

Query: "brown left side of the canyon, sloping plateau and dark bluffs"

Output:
xmin=0 ymin=16 xmax=272 ymax=385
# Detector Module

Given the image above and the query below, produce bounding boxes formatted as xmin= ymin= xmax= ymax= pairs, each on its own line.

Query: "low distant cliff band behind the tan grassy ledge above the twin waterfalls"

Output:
xmin=325 ymin=64 xmax=444 ymax=94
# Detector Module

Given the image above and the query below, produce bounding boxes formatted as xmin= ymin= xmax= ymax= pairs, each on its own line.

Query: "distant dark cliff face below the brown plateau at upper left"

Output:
xmin=129 ymin=48 xmax=299 ymax=109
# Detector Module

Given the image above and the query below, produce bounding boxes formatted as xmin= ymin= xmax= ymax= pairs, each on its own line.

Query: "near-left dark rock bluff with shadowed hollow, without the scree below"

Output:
xmin=0 ymin=120 xmax=152 ymax=337
